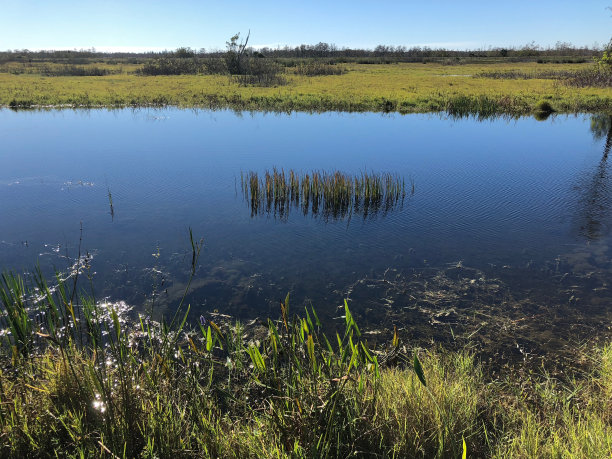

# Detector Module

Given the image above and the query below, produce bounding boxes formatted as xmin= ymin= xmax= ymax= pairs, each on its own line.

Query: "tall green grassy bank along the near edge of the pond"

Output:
xmin=0 ymin=264 xmax=612 ymax=458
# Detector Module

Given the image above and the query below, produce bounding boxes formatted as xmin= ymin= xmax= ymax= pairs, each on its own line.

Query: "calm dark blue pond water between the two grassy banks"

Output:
xmin=0 ymin=109 xmax=612 ymax=366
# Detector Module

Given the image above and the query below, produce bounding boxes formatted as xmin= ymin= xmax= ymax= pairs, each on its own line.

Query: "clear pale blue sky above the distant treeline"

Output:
xmin=0 ymin=0 xmax=612 ymax=51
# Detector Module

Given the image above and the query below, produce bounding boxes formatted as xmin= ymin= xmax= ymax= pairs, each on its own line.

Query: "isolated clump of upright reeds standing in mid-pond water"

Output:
xmin=240 ymin=168 xmax=414 ymax=220
